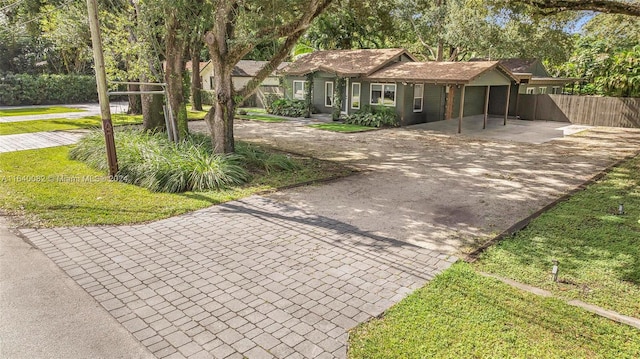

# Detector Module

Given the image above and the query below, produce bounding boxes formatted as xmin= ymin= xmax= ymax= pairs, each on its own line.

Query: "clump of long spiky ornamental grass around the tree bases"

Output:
xmin=69 ymin=130 xmax=298 ymax=193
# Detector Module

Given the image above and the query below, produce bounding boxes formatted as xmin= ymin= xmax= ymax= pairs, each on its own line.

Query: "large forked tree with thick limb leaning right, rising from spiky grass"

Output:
xmin=205 ymin=0 xmax=331 ymax=153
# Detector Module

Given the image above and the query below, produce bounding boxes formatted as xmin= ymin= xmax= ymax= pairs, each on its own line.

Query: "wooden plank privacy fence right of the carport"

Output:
xmin=516 ymin=94 xmax=640 ymax=128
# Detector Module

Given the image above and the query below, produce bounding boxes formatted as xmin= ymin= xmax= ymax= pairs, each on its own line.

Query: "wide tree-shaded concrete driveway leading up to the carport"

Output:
xmin=192 ymin=119 xmax=640 ymax=254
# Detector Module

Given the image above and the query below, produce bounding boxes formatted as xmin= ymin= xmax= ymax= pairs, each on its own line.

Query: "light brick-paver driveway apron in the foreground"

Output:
xmin=21 ymin=196 xmax=456 ymax=358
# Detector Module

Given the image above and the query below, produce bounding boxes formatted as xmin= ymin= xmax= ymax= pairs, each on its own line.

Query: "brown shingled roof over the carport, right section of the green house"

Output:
xmin=368 ymin=61 xmax=517 ymax=84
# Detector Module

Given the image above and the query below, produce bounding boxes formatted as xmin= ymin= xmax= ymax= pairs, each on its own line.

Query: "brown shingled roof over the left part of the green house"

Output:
xmin=284 ymin=48 xmax=416 ymax=76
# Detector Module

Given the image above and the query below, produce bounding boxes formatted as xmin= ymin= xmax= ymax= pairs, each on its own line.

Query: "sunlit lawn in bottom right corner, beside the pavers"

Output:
xmin=349 ymin=263 xmax=640 ymax=359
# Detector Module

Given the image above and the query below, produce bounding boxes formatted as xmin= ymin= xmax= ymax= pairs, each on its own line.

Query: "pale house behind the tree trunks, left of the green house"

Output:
xmin=186 ymin=60 xmax=289 ymax=107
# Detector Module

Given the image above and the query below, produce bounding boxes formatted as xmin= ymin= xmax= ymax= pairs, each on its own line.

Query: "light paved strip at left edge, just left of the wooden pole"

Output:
xmin=0 ymin=130 xmax=86 ymax=153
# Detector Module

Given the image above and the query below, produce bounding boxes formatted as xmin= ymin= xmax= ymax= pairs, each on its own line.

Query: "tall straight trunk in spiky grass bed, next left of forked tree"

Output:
xmin=164 ymin=13 xmax=189 ymax=138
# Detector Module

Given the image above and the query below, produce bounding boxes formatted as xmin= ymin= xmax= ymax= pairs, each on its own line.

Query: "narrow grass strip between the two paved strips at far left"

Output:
xmin=0 ymin=114 xmax=142 ymax=135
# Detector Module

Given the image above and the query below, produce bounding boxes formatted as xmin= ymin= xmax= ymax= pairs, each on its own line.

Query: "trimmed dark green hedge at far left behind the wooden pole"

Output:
xmin=0 ymin=74 xmax=98 ymax=106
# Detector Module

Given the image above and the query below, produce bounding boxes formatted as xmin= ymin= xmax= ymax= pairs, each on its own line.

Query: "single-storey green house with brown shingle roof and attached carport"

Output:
xmin=283 ymin=49 xmax=517 ymax=125
